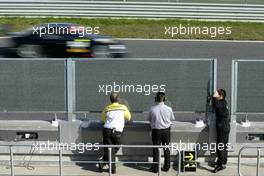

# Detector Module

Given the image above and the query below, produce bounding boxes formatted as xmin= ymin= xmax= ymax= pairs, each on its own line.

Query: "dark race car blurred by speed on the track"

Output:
xmin=0 ymin=23 xmax=127 ymax=58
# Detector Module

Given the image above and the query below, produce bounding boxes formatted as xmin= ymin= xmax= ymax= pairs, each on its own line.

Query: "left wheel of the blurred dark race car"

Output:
xmin=17 ymin=44 xmax=44 ymax=58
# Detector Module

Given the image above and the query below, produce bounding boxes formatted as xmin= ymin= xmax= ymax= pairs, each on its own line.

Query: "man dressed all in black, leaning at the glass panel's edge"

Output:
xmin=213 ymin=89 xmax=230 ymax=173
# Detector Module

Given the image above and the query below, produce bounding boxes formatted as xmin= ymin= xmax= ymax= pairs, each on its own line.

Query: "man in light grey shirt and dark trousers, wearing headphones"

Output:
xmin=148 ymin=92 xmax=175 ymax=173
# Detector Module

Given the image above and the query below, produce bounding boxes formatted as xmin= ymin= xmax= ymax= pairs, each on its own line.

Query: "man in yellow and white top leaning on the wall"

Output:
xmin=99 ymin=92 xmax=132 ymax=174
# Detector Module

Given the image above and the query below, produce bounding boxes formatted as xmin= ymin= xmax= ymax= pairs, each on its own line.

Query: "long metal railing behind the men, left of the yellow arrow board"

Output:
xmin=0 ymin=144 xmax=181 ymax=176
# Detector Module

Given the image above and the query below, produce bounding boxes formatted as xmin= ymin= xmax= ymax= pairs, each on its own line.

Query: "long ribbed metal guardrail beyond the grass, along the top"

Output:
xmin=0 ymin=0 xmax=264 ymax=22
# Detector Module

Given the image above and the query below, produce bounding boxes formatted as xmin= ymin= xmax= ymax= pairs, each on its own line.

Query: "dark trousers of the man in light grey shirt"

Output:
xmin=152 ymin=128 xmax=170 ymax=168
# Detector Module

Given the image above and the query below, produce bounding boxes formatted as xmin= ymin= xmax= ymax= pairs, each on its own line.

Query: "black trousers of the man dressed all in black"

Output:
xmin=216 ymin=126 xmax=230 ymax=166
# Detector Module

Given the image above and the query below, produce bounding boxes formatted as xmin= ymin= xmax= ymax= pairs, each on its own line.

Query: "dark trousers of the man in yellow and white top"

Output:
xmin=103 ymin=128 xmax=122 ymax=169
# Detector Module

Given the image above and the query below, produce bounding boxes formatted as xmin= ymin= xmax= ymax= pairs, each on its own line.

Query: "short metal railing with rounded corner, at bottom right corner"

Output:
xmin=237 ymin=146 xmax=264 ymax=176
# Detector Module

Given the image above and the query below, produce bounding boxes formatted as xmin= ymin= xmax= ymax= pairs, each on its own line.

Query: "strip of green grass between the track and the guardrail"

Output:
xmin=0 ymin=17 xmax=264 ymax=40
